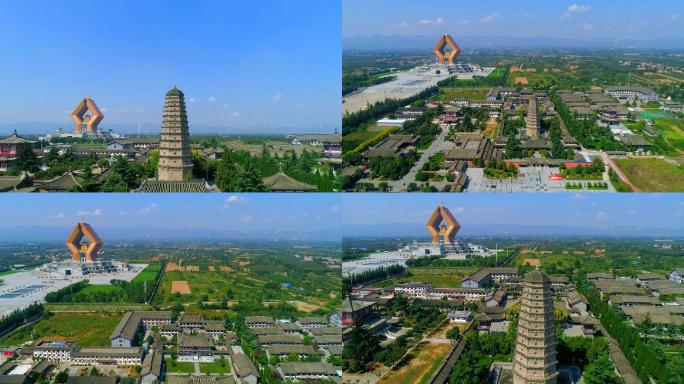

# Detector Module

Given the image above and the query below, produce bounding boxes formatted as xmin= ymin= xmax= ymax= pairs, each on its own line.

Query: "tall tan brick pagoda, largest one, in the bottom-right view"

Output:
xmin=513 ymin=270 xmax=558 ymax=384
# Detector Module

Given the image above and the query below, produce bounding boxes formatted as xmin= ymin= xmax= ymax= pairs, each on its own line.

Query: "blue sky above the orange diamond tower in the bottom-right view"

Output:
xmin=342 ymin=193 xmax=684 ymax=229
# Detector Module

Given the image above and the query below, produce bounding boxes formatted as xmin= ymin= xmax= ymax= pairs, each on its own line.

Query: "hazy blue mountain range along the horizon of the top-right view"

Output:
xmin=342 ymin=33 xmax=684 ymax=52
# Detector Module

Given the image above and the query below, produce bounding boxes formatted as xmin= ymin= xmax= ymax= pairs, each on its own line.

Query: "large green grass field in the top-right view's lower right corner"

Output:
xmin=615 ymin=158 xmax=684 ymax=192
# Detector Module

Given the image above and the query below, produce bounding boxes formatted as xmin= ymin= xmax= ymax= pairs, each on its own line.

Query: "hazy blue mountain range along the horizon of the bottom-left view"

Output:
xmin=0 ymin=226 xmax=341 ymax=243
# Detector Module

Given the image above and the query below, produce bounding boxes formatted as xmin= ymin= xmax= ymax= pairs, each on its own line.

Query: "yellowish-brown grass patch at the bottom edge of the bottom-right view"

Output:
xmin=378 ymin=344 xmax=451 ymax=384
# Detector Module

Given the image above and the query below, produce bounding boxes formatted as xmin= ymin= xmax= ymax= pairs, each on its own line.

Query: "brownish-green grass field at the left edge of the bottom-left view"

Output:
xmin=0 ymin=312 xmax=121 ymax=347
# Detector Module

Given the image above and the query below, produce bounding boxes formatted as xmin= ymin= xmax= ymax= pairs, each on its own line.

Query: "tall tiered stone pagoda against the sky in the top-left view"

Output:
xmin=157 ymin=87 xmax=192 ymax=181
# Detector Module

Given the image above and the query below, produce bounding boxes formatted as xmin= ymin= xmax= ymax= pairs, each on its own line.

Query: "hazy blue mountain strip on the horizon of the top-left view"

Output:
xmin=0 ymin=122 xmax=341 ymax=137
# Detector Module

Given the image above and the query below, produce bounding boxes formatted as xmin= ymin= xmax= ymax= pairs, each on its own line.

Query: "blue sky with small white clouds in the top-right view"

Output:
xmin=342 ymin=0 xmax=684 ymax=39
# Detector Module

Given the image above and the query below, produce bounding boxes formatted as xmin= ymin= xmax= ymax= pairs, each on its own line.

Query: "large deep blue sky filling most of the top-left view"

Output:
xmin=0 ymin=0 xmax=341 ymax=130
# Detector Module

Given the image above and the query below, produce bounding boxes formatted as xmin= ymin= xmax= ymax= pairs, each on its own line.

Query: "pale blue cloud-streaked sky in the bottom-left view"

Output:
xmin=0 ymin=193 xmax=342 ymax=232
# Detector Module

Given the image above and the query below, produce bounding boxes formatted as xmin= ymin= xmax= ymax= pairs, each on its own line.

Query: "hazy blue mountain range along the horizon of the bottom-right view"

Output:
xmin=342 ymin=223 xmax=684 ymax=239
